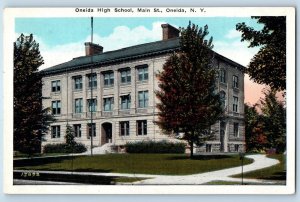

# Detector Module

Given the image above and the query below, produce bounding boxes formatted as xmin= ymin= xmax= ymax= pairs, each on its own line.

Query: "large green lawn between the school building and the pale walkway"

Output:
xmin=14 ymin=154 xmax=252 ymax=175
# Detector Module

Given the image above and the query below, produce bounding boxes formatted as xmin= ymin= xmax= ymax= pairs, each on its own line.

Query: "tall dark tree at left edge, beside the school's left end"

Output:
xmin=14 ymin=34 xmax=52 ymax=155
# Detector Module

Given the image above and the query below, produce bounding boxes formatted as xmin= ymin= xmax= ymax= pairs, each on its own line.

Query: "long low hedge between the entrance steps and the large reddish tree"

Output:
xmin=125 ymin=141 xmax=185 ymax=154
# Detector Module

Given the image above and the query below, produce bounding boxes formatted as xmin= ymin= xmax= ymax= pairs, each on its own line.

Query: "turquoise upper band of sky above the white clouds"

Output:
xmin=15 ymin=17 xmax=259 ymax=47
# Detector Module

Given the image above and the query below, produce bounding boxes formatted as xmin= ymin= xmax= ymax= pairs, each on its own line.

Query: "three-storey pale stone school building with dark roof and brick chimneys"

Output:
xmin=42 ymin=24 xmax=245 ymax=152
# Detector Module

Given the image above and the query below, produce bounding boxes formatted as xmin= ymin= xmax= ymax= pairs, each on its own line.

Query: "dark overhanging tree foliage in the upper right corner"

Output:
xmin=236 ymin=16 xmax=286 ymax=90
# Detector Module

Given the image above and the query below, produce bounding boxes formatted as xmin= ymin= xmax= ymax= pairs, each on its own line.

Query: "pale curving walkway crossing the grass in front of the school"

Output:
xmin=15 ymin=154 xmax=280 ymax=185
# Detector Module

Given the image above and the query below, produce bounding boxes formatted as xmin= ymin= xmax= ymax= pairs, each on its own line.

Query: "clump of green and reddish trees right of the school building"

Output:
xmin=245 ymin=90 xmax=286 ymax=153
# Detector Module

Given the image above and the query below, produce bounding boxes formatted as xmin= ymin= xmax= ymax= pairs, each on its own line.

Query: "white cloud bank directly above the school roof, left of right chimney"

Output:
xmin=37 ymin=22 xmax=164 ymax=70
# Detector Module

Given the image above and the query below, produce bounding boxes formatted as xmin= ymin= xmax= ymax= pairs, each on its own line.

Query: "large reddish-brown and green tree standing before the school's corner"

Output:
xmin=156 ymin=22 xmax=223 ymax=157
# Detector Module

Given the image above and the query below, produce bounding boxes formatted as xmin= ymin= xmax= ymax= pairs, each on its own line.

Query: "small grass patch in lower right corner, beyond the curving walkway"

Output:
xmin=232 ymin=154 xmax=286 ymax=180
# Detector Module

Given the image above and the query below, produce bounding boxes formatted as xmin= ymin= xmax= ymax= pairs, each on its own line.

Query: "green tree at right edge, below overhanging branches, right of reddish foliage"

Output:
xmin=261 ymin=90 xmax=286 ymax=153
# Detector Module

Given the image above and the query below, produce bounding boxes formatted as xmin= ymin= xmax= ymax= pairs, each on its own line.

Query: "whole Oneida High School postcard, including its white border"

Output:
xmin=3 ymin=7 xmax=296 ymax=194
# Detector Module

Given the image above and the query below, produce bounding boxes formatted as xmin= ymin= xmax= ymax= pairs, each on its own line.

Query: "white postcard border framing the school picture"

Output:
xmin=3 ymin=7 xmax=296 ymax=194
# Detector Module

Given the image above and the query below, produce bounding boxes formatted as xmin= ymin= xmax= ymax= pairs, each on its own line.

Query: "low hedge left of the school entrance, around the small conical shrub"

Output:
xmin=44 ymin=143 xmax=86 ymax=153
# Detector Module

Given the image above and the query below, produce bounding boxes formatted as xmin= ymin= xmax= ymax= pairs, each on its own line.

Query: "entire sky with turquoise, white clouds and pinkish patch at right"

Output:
xmin=15 ymin=17 xmax=262 ymax=103
